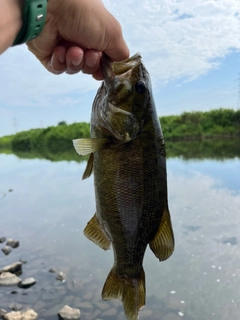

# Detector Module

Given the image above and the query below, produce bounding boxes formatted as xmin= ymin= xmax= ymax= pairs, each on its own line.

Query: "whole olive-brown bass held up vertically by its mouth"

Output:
xmin=73 ymin=53 xmax=174 ymax=320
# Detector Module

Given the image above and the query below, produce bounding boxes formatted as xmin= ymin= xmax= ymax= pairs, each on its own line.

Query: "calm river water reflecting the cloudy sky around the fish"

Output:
xmin=0 ymin=141 xmax=240 ymax=320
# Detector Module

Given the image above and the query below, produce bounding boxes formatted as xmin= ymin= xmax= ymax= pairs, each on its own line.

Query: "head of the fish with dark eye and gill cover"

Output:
xmin=95 ymin=53 xmax=151 ymax=143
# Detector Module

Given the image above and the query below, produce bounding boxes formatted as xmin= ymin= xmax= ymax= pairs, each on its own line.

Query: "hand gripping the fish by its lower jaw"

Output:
xmin=27 ymin=0 xmax=129 ymax=80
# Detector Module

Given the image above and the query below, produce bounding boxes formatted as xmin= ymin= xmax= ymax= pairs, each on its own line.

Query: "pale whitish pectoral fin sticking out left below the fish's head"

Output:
xmin=73 ymin=138 xmax=109 ymax=156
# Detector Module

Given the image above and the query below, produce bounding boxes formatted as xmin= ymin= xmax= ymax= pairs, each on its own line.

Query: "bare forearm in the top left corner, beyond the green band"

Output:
xmin=0 ymin=0 xmax=23 ymax=54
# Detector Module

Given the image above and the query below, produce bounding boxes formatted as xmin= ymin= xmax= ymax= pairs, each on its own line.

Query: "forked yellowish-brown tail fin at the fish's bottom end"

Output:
xmin=102 ymin=268 xmax=145 ymax=320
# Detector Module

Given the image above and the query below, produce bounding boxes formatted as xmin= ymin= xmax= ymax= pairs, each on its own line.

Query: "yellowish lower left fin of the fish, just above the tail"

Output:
xmin=83 ymin=214 xmax=111 ymax=250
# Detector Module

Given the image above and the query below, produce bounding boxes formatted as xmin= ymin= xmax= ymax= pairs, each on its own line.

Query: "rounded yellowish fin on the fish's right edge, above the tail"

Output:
xmin=149 ymin=209 xmax=174 ymax=261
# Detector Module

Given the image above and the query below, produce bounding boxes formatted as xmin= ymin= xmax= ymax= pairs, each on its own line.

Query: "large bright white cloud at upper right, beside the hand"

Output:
xmin=108 ymin=0 xmax=240 ymax=83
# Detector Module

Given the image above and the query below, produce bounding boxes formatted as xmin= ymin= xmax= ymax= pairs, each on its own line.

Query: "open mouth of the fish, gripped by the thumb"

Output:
xmin=101 ymin=52 xmax=142 ymax=83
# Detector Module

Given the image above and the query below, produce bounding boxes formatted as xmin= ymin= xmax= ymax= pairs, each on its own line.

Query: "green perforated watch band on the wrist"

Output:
xmin=12 ymin=0 xmax=48 ymax=46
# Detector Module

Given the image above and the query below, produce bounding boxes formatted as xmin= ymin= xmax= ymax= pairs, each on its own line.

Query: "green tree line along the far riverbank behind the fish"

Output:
xmin=0 ymin=109 xmax=240 ymax=161
